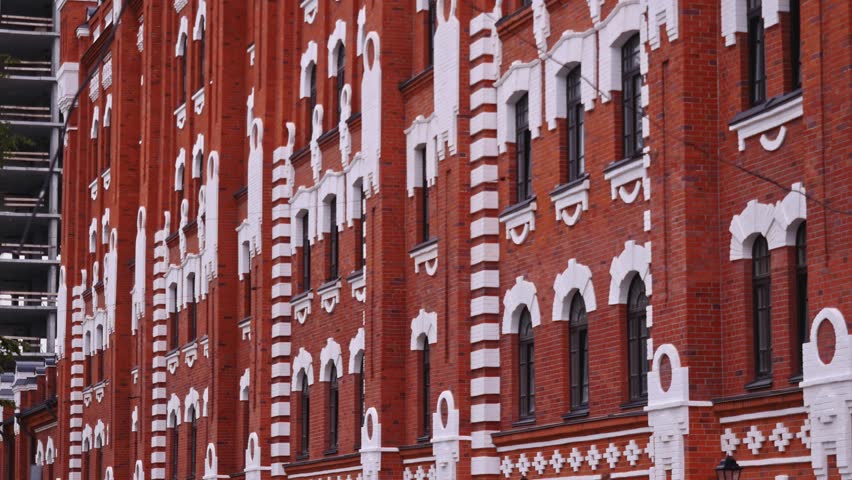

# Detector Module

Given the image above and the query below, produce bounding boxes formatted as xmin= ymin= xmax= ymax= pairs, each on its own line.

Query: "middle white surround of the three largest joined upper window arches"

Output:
xmin=544 ymin=30 xmax=598 ymax=130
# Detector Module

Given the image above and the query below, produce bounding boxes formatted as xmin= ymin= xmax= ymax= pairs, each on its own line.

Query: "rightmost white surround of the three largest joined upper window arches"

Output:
xmin=598 ymin=0 xmax=648 ymax=103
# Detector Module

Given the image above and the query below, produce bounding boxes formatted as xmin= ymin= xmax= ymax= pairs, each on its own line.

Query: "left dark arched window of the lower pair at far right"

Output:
xmin=751 ymin=235 xmax=772 ymax=380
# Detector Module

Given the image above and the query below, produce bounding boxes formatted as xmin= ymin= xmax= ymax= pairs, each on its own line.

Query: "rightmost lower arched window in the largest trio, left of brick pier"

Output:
xmin=627 ymin=275 xmax=648 ymax=402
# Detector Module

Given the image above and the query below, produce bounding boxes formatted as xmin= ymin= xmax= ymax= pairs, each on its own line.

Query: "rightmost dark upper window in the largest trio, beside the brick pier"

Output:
xmin=621 ymin=34 xmax=643 ymax=158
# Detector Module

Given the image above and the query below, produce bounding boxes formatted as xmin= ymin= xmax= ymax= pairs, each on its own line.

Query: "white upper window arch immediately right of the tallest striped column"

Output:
xmin=494 ymin=59 xmax=541 ymax=153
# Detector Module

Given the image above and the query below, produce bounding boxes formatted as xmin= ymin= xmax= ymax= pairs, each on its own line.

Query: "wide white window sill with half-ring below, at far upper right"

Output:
xmin=728 ymin=89 xmax=804 ymax=152
